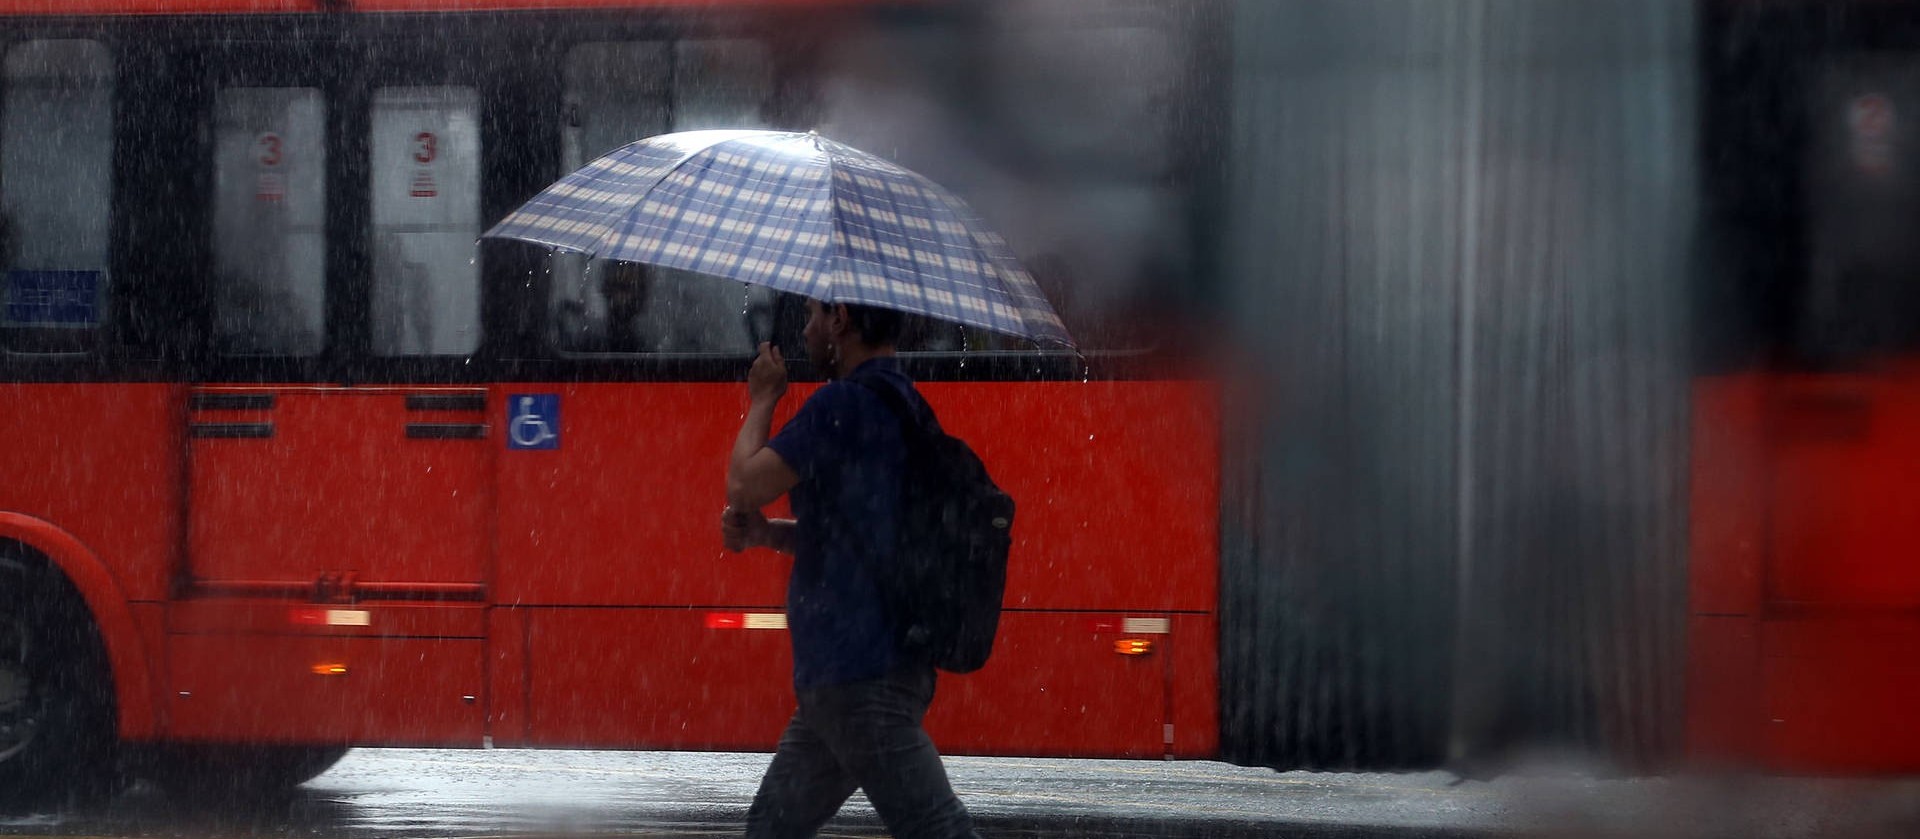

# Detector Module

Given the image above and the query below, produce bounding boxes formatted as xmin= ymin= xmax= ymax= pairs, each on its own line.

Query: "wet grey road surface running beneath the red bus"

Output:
xmin=0 ymin=749 xmax=1920 ymax=839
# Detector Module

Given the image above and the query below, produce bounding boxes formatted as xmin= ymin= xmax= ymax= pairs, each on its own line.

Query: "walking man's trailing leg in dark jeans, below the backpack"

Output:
xmin=801 ymin=666 xmax=975 ymax=839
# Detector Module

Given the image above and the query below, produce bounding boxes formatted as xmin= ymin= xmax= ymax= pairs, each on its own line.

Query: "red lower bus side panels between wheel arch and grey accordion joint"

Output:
xmin=142 ymin=382 xmax=1217 ymax=756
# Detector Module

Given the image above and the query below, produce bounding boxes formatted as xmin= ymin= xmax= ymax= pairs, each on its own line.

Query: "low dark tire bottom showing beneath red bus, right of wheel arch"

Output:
xmin=148 ymin=745 xmax=348 ymax=803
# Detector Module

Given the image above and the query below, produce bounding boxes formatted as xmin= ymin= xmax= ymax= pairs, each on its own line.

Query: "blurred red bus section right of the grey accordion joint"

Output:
xmin=1686 ymin=2 xmax=1920 ymax=774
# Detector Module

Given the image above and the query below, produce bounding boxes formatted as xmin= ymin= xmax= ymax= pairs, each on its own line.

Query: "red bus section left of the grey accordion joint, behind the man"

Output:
xmin=0 ymin=0 xmax=1219 ymax=793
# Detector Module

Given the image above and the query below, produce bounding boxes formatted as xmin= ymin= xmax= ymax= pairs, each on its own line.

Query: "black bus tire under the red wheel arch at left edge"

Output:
xmin=0 ymin=543 xmax=121 ymax=810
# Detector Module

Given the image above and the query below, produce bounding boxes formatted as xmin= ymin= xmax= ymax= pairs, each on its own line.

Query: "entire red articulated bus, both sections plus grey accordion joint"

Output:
xmin=11 ymin=0 xmax=1920 ymax=797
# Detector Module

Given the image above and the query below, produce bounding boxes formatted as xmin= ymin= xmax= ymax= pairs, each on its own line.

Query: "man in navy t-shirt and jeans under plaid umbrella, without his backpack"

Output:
xmin=722 ymin=300 xmax=975 ymax=839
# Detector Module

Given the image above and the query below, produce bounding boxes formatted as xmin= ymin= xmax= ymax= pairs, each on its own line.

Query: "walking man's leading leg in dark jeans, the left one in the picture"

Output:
xmin=747 ymin=710 xmax=858 ymax=839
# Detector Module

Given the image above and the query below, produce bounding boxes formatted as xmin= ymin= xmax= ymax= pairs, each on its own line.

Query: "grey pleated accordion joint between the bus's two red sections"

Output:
xmin=1221 ymin=0 xmax=1699 ymax=770
